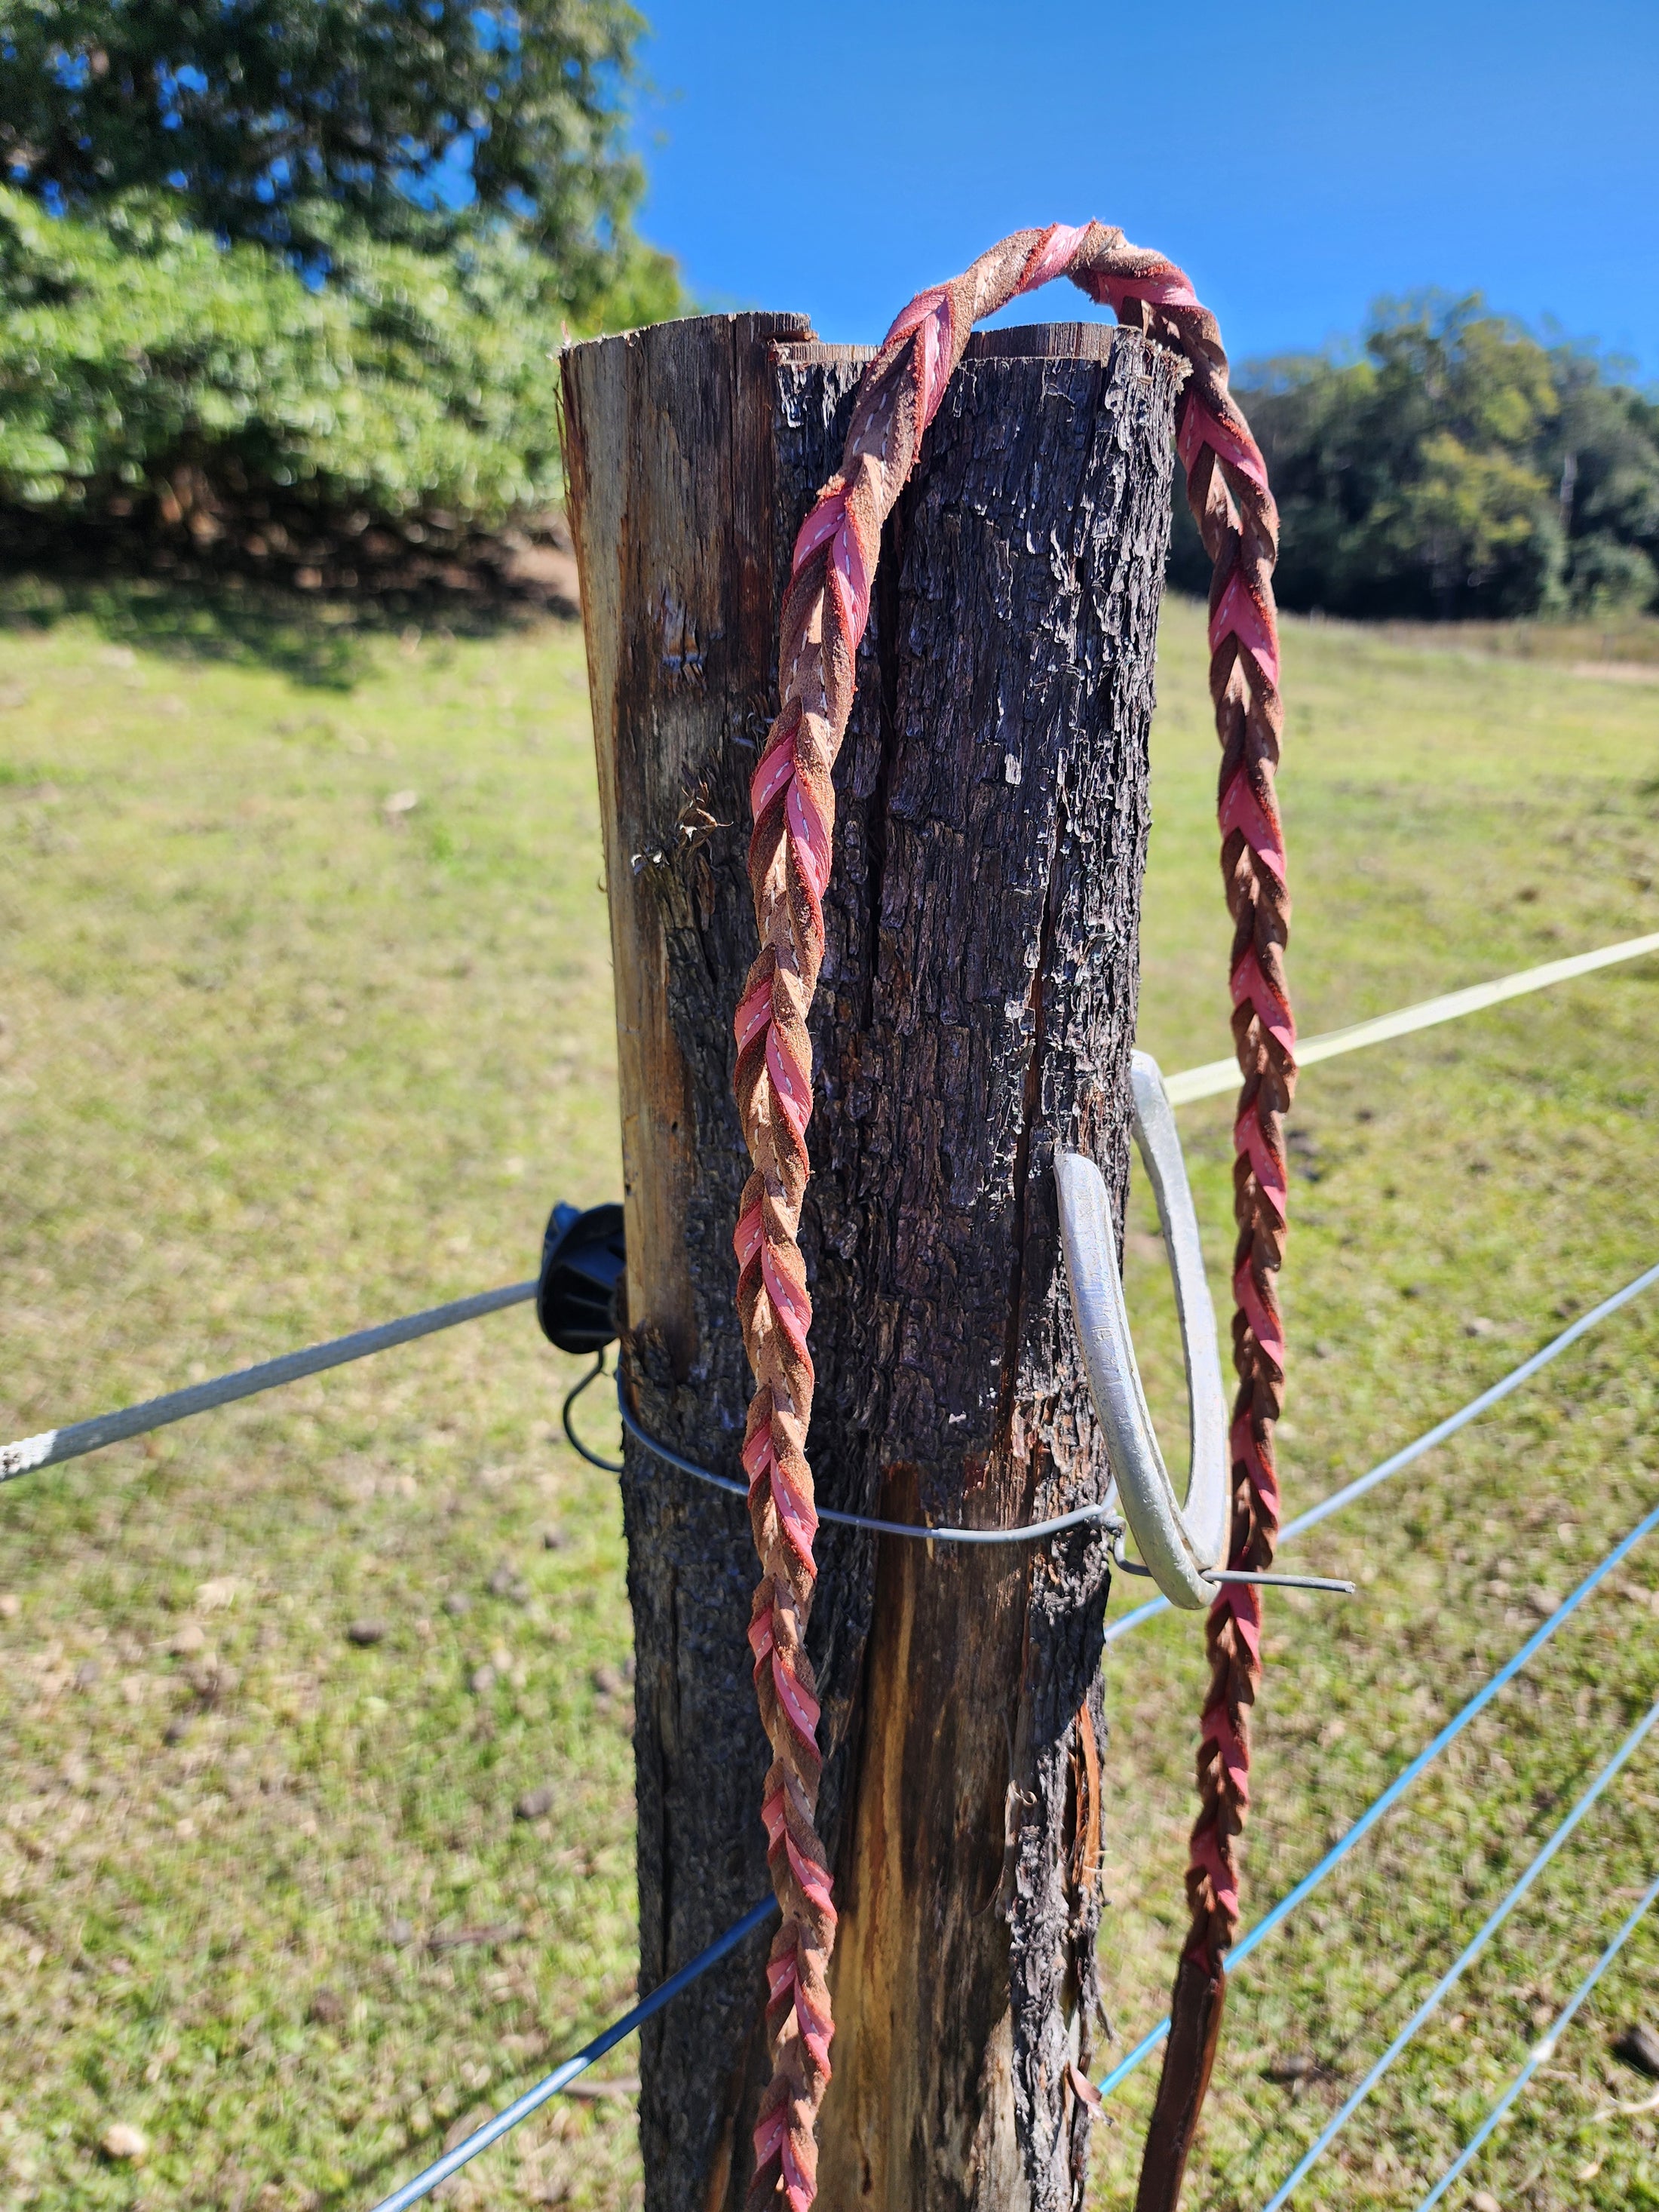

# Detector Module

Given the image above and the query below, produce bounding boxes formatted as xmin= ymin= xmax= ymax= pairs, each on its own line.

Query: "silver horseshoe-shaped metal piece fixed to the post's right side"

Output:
xmin=1055 ymin=1053 xmax=1228 ymax=1610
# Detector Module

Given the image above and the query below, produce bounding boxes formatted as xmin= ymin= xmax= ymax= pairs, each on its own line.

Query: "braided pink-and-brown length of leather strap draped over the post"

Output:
xmin=734 ymin=223 xmax=1294 ymax=2212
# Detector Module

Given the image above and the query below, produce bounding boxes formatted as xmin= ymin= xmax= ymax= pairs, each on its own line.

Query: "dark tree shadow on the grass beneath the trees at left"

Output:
xmin=0 ymin=575 xmax=579 ymax=692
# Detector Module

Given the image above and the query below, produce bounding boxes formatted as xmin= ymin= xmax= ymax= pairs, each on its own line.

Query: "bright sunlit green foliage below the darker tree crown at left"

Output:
xmin=0 ymin=188 xmax=675 ymax=524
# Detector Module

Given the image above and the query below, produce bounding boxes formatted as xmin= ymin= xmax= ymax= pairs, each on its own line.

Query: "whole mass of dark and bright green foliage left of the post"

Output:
xmin=0 ymin=0 xmax=679 ymax=529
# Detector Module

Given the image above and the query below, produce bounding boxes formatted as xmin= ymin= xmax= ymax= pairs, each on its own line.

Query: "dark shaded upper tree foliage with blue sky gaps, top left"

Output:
xmin=0 ymin=0 xmax=644 ymax=294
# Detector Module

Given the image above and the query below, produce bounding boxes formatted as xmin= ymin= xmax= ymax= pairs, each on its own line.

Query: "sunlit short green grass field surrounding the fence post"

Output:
xmin=0 ymin=595 xmax=1659 ymax=2212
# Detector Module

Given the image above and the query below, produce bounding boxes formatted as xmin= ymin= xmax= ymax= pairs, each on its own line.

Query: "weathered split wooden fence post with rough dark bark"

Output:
xmin=564 ymin=314 xmax=1177 ymax=2212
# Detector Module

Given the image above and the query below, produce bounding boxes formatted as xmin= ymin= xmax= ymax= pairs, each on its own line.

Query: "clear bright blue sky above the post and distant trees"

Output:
xmin=635 ymin=0 xmax=1659 ymax=380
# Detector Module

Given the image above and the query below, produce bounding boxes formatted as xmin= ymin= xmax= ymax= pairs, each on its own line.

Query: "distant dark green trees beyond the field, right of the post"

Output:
xmin=1170 ymin=294 xmax=1659 ymax=617
